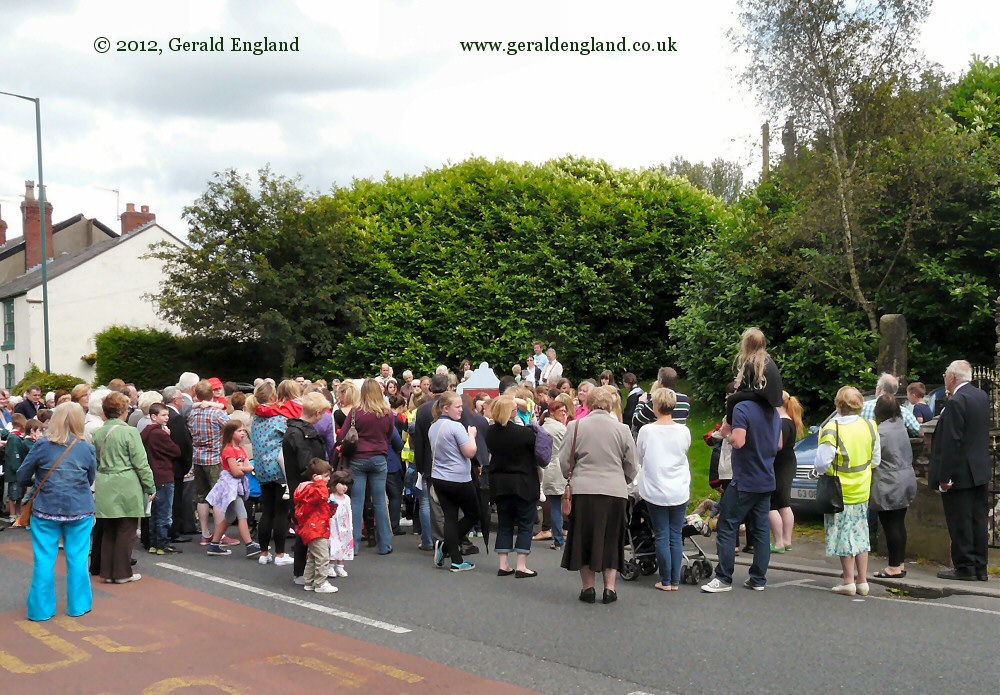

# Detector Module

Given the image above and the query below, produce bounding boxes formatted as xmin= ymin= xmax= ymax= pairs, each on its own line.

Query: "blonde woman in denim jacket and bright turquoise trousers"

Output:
xmin=17 ymin=403 xmax=97 ymax=620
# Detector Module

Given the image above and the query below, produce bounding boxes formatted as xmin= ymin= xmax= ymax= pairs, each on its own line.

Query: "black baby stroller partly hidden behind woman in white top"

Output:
xmin=621 ymin=495 xmax=712 ymax=584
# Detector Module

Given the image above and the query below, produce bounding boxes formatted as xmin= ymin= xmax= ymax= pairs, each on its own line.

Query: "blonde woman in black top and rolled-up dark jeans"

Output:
xmin=486 ymin=395 xmax=540 ymax=579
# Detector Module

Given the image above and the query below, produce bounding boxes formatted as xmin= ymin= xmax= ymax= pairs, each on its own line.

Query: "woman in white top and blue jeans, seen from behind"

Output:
xmin=636 ymin=388 xmax=691 ymax=591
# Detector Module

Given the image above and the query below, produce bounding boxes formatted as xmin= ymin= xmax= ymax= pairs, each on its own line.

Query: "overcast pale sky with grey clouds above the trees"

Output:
xmin=0 ymin=0 xmax=1000 ymax=237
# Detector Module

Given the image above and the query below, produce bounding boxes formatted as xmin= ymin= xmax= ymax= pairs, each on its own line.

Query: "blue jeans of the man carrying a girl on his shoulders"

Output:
xmin=715 ymin=481 xmax=771 ymax=586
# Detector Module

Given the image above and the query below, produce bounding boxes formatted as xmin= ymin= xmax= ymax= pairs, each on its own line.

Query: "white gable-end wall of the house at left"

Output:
xmin=21 ymin=226 xmax=180 ymax=382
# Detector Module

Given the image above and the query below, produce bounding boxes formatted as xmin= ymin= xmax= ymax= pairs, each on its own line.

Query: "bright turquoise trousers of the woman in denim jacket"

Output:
xmin=28 ymin=516 xmax=94 ymax=620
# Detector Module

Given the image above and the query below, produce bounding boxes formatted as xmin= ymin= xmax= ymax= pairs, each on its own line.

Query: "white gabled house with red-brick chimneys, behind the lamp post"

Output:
xmin=0 ymin=182 xmax=184 ymax=388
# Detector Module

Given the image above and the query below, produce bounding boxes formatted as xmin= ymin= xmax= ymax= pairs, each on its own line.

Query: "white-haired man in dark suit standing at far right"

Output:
xmin=927 ymin=360 xmax=992 ymax=582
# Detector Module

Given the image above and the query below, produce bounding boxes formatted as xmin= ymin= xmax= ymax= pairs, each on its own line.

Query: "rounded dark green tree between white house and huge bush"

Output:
xmin=153 ymin=168 xmax=362 ymax=374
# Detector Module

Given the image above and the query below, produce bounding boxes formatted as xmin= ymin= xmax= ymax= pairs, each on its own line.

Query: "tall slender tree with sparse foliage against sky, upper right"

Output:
xmin=732 ymin=0 xmax=930 ymax=332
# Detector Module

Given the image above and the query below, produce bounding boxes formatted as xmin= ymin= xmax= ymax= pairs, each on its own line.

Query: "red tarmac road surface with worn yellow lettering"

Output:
xmin=0 ymin=543 xmax=531 ymax=695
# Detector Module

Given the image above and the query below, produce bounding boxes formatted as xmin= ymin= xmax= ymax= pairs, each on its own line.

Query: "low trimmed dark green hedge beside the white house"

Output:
xmin=96 ymin=326 xmax=281 ymax=389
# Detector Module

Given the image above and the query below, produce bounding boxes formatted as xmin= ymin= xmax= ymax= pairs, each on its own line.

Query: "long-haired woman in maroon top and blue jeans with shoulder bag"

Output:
xmin=337 ymin=379 xmax=396 ymax=555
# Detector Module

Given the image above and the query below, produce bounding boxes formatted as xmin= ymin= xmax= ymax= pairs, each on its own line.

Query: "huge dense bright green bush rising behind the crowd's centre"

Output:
xmin=320 ymin=157 xmax=727 ymax=381
